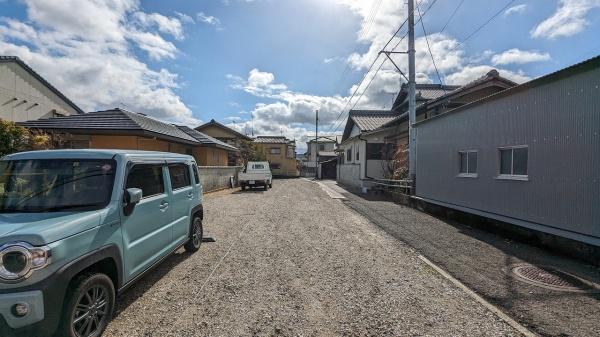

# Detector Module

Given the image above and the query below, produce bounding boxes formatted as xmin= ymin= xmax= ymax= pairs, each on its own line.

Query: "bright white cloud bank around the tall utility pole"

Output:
xmin=227 ymin=0 xmax=540 ymax=147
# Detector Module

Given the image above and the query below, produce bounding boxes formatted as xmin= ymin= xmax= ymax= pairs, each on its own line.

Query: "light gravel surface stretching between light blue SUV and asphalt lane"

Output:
xmin=105 ymin=179 xmax=519 ymax=337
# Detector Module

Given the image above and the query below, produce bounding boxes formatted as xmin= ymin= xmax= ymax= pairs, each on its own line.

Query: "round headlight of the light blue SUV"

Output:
xmin=0 ymin=242 xmax=50 ymax=282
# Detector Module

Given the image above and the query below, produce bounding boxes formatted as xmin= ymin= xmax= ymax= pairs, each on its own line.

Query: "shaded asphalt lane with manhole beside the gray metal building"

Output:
xmin=326 ymin=182 xmax=600 ymax=337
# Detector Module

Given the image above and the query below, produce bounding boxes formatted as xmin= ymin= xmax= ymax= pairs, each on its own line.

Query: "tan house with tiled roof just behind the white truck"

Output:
xmin=254 ymin=136 xmax=300 ymax=177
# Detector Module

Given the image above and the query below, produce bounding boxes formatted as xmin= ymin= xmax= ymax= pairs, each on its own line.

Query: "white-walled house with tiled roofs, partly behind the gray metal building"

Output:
xmin=338 ymin=70 xmax=517 ymax=188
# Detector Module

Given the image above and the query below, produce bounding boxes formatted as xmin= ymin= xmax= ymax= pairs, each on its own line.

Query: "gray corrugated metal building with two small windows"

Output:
xmin=416 ymin=56 xmax=600 ymax=246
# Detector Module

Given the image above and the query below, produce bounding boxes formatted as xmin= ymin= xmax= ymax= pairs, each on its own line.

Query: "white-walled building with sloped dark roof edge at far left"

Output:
xmin=0 ymin=56 xmax=83 ymax=122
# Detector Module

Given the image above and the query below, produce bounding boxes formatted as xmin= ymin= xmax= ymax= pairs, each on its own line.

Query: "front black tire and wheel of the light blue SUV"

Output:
xmin=56 ymin=273 xmax=115 ymax=337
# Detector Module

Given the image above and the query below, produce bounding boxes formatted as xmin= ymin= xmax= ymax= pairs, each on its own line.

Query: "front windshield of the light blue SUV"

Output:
xmin=0 ymin=159 xmax=116 ymax=213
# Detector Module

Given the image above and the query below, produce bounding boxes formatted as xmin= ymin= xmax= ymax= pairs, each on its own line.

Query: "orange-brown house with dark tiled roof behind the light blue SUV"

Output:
xmin=17 ymin=108 xmax=238 ymax=166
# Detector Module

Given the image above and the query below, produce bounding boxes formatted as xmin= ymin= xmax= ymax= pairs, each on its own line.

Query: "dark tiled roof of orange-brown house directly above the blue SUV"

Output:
xmin=18 ymin=108 xmax=198 ymax=144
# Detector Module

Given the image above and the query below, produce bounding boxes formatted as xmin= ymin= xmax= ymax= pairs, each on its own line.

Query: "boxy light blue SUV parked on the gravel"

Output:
xmin=0 ymin=150 xmax=203 ymax=337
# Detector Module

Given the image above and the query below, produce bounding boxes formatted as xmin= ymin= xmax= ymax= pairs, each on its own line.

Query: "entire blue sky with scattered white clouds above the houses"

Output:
xmin=0 ymin=0 xmax=600 ymax=148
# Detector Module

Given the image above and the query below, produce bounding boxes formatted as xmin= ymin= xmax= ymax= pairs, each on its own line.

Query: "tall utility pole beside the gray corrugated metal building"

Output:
xmin=408 ymin=0 xmax=417 ymax=194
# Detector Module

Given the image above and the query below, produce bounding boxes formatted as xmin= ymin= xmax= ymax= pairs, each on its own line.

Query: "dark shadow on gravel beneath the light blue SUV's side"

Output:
xmin=114 ymin=249 xmax=193 ymax=317
